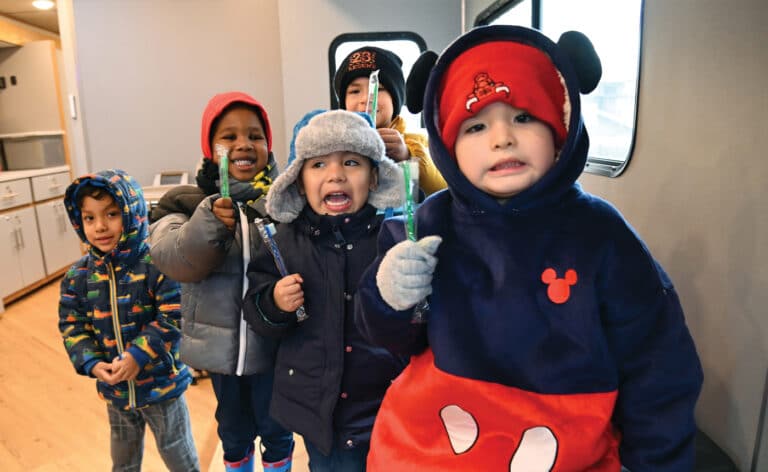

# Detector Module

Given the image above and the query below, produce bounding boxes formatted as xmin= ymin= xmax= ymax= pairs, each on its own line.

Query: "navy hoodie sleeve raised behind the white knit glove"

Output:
xmin=355 ymin=220 xmax=429 ymax=355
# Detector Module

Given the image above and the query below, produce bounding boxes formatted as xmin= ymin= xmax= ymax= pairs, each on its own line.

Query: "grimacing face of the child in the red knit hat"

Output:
xmin=455 ymin=102 xmax=555 ymax=198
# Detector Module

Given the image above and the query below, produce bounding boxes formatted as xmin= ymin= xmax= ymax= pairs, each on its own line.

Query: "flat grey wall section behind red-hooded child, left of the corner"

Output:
xmin=68 ymin=0 xmax=286 ymax=185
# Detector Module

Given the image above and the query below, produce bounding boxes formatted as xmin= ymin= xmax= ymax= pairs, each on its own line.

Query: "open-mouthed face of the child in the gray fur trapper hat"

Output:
xmin=297 ymin=151 xmax=378 ymax=215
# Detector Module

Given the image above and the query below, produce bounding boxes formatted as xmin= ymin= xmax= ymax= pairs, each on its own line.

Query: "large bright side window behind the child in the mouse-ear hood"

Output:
xmin=475 ymin=0 xmax=643 ymax=177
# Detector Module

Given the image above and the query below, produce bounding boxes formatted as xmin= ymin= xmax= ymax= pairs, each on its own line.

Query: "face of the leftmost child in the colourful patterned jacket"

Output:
xmin=80 ymin=196 xmax=123 ymax=254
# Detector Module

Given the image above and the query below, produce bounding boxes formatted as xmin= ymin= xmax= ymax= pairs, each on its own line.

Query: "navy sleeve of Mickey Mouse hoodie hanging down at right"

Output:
xmin=598 ymin=217 xmax=703 ymax=472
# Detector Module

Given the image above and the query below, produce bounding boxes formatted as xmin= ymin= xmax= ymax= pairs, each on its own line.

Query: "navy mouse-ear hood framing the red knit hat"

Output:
xmin=420 ymin=25 xmax=601 ymax=214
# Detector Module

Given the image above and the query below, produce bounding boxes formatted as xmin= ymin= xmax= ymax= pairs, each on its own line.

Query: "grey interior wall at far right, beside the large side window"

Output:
xmin=465 ymin=0 xmax=768 ymax=470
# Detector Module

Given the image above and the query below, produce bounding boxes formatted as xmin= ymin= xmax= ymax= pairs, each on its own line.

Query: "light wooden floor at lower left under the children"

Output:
xmin=0 ymin=279 xmax=309 ymax=472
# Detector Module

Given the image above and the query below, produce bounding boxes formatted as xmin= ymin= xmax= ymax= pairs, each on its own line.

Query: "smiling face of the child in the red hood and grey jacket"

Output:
xmin=211 ymin=106 xmax=269 ymax=182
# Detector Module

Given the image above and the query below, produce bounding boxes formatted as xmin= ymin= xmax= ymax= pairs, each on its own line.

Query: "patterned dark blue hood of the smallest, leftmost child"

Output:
xmin=64 ymin=169 xmax=149 ymax=265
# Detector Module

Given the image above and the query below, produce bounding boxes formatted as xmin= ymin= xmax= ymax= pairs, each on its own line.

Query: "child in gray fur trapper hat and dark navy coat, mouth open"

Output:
xmin=243 ymin=110 xmax=408 ymax=470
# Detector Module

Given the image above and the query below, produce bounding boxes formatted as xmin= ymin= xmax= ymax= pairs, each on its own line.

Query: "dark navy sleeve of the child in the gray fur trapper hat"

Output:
xmin=243 ymin=231 xmax=298 ymax=338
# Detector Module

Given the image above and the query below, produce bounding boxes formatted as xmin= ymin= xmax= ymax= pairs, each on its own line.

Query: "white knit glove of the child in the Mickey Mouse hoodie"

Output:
xmin=376 ymin=236 xmax=443 ymax=311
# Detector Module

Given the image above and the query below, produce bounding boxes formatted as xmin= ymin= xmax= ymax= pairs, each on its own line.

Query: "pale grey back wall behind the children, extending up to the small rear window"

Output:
xmin=63 ymin=0 xmax=460 ymax=185
